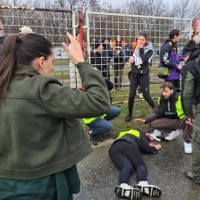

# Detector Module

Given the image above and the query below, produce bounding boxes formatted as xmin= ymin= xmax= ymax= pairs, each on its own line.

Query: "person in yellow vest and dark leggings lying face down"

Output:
xmin=109 ymin=129 xmax=162 ymax=200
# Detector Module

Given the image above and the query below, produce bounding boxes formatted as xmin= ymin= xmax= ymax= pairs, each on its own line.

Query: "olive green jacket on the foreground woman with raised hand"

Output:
xmin=0 ymin=63 xmax=110 ymax=180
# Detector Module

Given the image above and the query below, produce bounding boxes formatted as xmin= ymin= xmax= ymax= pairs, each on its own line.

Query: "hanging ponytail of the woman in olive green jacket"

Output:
xmin=0 ymin=35 xmax=20 ymax=105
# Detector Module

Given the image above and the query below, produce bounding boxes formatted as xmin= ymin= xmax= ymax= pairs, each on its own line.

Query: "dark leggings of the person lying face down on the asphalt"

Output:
xmin=109 ymin=140 xmax=147 ymax=184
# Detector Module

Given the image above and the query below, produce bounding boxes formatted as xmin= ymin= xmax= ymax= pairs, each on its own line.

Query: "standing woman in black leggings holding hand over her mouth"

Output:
xmin=125 ymin=33 xmax=154 ymax=122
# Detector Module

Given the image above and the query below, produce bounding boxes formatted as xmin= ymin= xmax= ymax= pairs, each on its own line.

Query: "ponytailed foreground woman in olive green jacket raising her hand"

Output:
xmin=0 ymin=33 xmax=110 ymax=200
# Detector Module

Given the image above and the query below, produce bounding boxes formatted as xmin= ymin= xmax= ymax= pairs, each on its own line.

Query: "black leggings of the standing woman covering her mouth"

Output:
xmin=128 ymin=74 xmax=155 ymax=115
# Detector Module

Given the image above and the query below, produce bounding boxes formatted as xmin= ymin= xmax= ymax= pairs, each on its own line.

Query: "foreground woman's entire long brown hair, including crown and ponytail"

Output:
xmin=0 ymin=33 xmax=53 ymax=105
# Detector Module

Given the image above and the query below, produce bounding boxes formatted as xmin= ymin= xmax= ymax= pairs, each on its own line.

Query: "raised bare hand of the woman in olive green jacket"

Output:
xmin=62 ymin=32 xmax=84 ymax=65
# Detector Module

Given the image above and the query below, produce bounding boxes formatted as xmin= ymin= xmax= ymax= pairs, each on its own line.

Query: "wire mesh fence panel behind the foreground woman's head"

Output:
xmin=0 ymin=6 xmax=73 ymax=84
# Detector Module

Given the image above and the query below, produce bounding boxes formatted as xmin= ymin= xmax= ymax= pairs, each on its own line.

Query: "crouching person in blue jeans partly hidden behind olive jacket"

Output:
xmin=83 ymin=107 xmax=121 ymax=145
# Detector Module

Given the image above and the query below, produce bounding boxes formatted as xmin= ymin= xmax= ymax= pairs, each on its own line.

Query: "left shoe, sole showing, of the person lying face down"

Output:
xmin=114 ymin=186 xmax=142 ymax=200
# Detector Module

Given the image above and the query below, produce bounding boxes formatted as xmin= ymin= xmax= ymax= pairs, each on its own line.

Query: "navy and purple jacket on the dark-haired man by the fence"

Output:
xmin=160 ymin=39 xmax=181 ymax=81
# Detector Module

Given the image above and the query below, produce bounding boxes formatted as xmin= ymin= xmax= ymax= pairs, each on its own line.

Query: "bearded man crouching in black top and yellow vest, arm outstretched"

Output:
xmin=135 ymin=82 xmax=192 ymax=153
